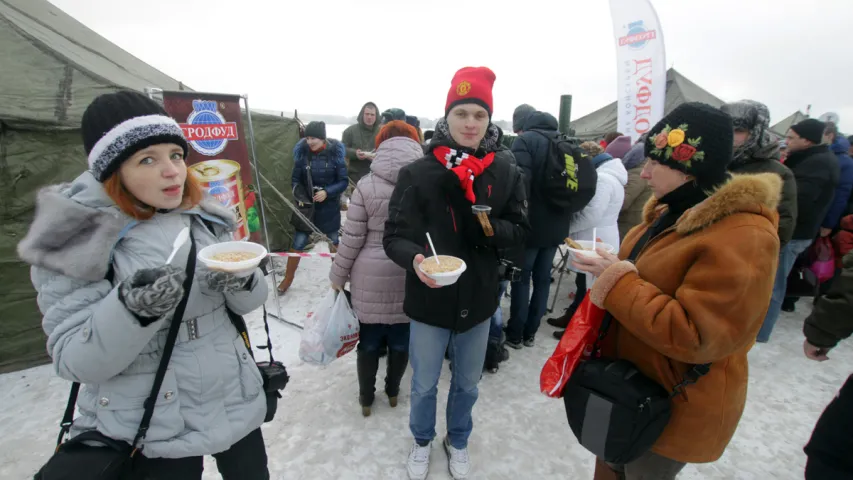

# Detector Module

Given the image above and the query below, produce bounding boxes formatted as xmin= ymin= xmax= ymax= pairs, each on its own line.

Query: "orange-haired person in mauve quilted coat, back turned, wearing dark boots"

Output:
xmin=329 ymin=120 xmax=423 ymax=416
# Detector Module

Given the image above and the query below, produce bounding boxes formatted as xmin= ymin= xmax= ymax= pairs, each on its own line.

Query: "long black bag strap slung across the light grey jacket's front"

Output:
xmin=56 ymin=231 xmax=196 ymax=455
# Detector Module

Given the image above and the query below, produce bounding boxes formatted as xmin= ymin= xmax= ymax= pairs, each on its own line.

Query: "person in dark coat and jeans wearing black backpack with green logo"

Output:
xmin=506 ymin=112 xmax=571 ymax=349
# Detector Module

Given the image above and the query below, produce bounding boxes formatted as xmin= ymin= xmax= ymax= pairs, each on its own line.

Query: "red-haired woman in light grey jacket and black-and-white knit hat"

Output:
xmin=18 ymin=92 xmax=269 ymax=480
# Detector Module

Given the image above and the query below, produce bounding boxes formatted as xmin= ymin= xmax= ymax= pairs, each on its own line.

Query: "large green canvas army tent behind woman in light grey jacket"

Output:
xmin=0 ymin=0 xmax=299 ymax=372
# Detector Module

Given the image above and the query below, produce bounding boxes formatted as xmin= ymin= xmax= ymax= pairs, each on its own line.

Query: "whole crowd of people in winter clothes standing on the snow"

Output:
xmin=19 ymin=63 xmax=853 ymax=480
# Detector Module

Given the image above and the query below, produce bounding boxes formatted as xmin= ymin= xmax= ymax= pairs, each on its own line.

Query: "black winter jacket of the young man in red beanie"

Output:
xmin=383 ymin=127 xmax=530 ymax=332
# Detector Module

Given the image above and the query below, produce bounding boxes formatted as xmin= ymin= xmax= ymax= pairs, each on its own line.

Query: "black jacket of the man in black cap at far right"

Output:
xmin=785 ymin=145 xmax=841 ymax=240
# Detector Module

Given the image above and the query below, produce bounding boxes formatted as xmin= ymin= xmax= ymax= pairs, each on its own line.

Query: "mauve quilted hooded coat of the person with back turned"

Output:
xmin=329 ymin=137 xmax=424 ymax=324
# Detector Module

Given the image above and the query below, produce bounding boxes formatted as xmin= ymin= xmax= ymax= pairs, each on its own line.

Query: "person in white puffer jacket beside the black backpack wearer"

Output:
xmin=549 ymin=142 xmax=628 ymax=339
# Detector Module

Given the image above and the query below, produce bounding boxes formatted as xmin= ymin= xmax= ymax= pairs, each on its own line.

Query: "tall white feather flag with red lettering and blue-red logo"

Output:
xmin=610 ymin=0 xmax=666 ymax=141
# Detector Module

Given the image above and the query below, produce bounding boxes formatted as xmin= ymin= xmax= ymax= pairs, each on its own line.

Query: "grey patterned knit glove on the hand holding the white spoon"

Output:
xmin=118 ymin=265 xmax=187 ymax=323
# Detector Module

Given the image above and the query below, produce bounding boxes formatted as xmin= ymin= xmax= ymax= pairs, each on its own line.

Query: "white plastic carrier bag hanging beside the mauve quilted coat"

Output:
xmin=299 ymin=289 xmax=359 ymax=365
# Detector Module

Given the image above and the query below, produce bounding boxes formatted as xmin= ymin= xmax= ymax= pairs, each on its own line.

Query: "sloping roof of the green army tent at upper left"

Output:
xmin=0 ymin=0 xmax=182 ymax=128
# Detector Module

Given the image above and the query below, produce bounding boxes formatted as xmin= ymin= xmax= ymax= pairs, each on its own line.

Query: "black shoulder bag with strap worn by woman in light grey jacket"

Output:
xmin=33 ymin=237 xmax=196 ymax=480
